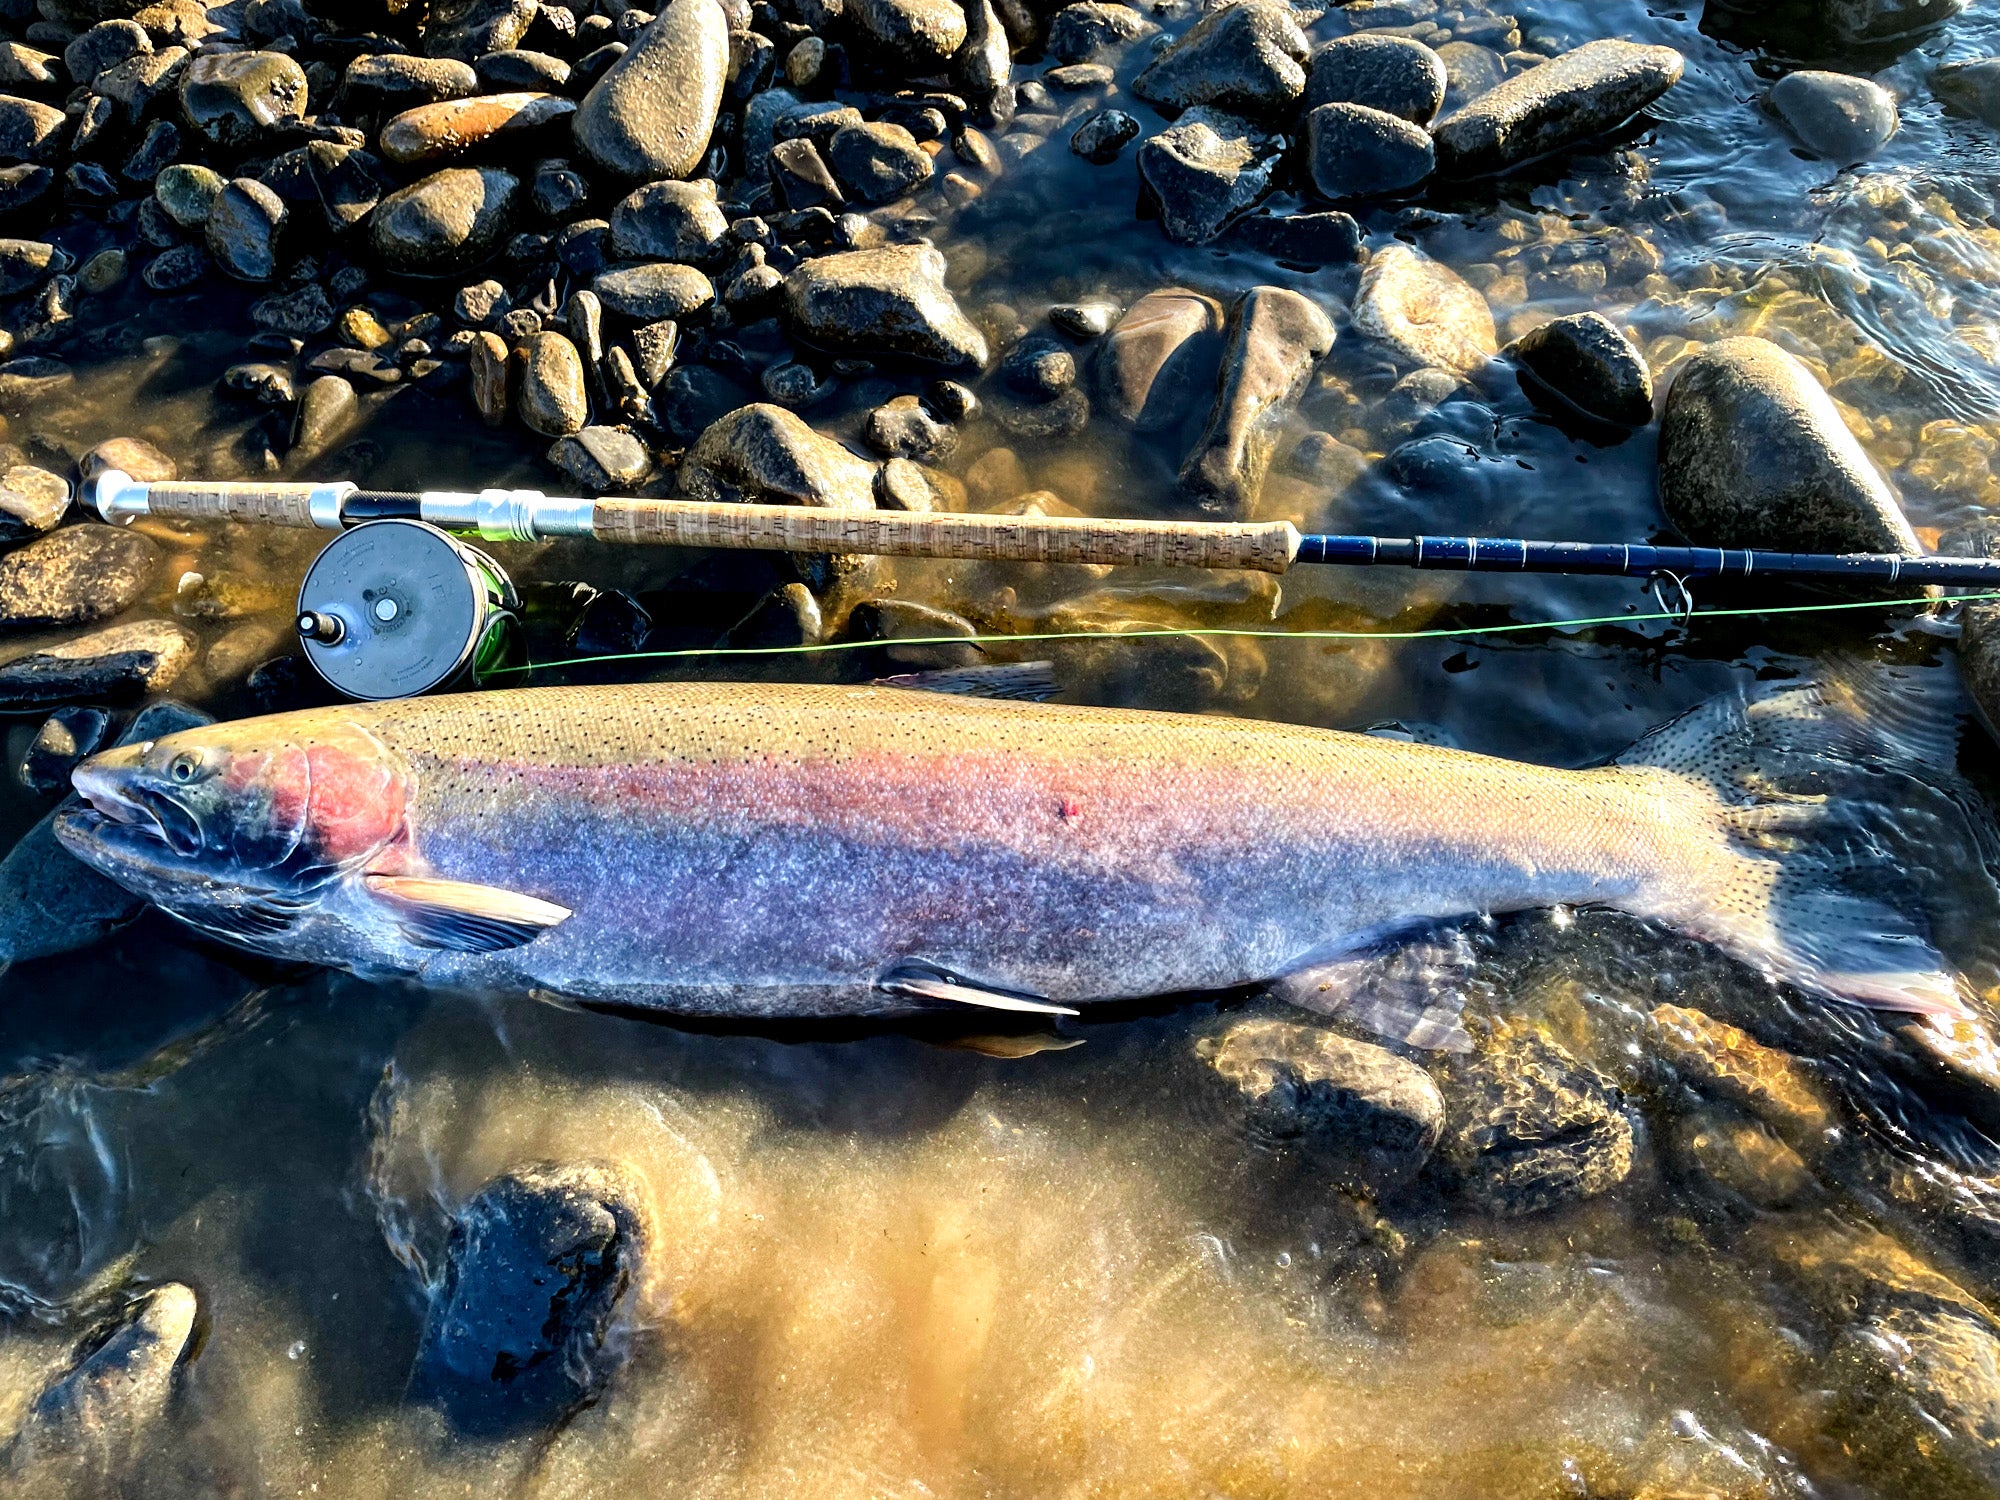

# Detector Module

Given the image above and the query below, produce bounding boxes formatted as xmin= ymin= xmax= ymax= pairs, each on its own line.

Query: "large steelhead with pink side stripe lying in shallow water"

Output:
xmin=60 ymin=682 xmax=1960 ymax=1044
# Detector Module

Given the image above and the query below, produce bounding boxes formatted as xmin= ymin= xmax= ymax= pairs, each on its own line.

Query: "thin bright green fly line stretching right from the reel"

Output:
xmin=484 ymin=592 xmax=2000 ymax=676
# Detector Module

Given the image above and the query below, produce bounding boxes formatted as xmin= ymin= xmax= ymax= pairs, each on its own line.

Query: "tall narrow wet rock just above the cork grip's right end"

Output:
xmin=1180 ymin=286 xmax=1334 ymax=520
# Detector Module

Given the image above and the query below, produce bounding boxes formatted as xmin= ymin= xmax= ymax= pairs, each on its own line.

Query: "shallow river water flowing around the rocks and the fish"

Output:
xmin=15 ymin=0 xmax=2000 ymax=1500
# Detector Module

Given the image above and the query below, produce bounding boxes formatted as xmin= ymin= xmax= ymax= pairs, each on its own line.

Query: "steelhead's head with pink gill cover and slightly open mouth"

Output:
xmin=56 ymin=712 xmax=408 ymax=938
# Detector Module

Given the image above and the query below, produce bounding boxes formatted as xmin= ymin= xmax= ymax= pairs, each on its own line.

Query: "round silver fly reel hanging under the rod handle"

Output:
xmin=298 ymin=520 xmax=520 ymax=698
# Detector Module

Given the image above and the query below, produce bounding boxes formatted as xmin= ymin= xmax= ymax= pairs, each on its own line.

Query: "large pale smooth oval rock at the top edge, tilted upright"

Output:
xmin=574 ymin=0 xmax=730 ymax=178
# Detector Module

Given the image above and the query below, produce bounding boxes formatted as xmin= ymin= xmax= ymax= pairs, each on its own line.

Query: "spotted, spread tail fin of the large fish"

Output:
xmin=1612 ymin=666 xmax=1996 ymax=1016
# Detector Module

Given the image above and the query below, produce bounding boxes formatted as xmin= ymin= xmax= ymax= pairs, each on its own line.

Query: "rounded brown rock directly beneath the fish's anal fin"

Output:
xmin=1196 ymin=1018 xmax=1444 ymax=1192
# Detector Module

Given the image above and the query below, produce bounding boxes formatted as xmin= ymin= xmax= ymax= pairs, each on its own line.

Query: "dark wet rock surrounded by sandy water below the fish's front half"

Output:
xmin=410 ymin=1162 xmax=652 ymax=1432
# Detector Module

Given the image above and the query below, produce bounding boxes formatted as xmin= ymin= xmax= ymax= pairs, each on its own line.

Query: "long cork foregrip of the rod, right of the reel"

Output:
xmin=590 ymin=506 xmax=1298 ymax=572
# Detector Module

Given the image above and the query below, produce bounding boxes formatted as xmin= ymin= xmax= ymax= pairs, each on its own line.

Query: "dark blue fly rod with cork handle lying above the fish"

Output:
xmin=84 ymin=470 xmax=2000 ymax=588
